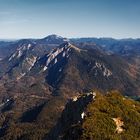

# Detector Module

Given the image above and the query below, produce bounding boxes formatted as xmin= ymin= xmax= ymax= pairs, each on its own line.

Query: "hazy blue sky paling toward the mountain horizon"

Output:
xmin=0 ymin=0 xmax=140 ymax=38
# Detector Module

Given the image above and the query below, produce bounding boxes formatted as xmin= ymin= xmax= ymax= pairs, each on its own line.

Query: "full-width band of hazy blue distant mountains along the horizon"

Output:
xmin=0 ymin=35 xmax=140 ymax=57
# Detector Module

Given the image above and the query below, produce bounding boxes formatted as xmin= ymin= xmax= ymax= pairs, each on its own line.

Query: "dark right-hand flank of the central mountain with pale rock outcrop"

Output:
xmin=55 ymin=44 xmax=139 ymax=95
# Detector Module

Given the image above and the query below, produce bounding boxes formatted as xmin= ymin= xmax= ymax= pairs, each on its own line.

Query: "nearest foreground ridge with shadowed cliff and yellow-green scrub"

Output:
xmin=46 ymin=91 xmax=140 ymax=140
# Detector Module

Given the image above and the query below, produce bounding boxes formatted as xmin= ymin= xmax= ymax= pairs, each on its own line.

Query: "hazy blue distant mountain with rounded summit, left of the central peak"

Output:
xmin=0 ymin=35 xmax=69 ymax=59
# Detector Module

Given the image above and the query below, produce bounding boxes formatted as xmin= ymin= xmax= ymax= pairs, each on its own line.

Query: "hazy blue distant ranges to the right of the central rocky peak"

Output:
xmin=71 ymin=38 xmax=140 ymax=56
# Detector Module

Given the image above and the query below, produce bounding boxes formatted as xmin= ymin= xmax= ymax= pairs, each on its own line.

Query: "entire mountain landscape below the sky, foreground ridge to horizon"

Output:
xmin=0 ymin=35 xmax=140 ymax=140
